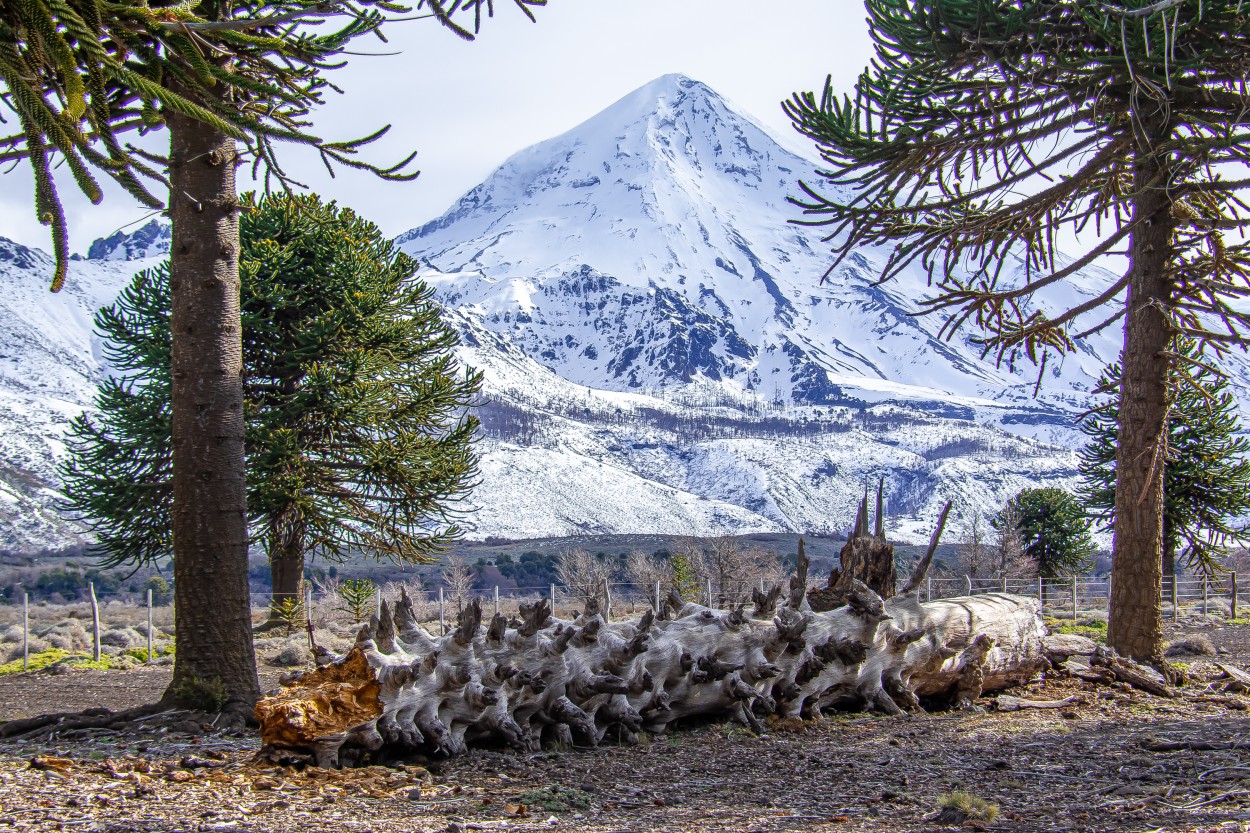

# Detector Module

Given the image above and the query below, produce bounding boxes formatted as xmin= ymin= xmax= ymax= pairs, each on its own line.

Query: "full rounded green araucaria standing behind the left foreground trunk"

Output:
xmin=63 ymin=195 xmax=480 ymax=603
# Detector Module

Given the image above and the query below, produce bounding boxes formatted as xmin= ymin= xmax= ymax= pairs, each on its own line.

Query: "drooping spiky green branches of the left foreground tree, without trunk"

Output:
xmin=0 ymin=0 xmax=546 ymax=291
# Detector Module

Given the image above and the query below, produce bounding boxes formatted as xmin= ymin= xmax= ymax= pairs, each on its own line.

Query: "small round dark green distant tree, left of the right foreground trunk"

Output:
xmin=1000 ymin=487 xmax=1095 ymax=578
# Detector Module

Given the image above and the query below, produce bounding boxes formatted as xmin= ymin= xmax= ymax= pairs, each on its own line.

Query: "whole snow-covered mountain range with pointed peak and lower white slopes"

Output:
xmin=0 ymin=75 xmax=1250 ymax=550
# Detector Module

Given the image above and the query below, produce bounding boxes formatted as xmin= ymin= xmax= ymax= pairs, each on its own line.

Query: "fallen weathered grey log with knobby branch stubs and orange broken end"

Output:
xmin=256 ymin=502 xmax=1065 ymax=765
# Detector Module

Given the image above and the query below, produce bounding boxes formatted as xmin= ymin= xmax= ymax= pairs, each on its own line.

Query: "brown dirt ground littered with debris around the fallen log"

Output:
xmin=7 ymin=623 xmax=1250 ymax=833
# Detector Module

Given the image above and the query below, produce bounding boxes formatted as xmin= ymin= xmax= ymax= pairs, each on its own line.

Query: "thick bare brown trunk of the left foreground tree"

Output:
xmin=165 ymin=101 xmax=260 ymax=702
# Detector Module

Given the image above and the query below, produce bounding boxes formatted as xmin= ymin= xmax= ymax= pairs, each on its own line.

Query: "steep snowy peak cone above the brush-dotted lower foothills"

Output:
xmin=400 ymin=75 xmax=1150 ymax=409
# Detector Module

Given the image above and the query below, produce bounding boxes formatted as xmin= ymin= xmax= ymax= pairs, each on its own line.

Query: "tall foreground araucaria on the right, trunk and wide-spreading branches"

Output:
xmin=786 ymin=0 xmax=1250 ymax=659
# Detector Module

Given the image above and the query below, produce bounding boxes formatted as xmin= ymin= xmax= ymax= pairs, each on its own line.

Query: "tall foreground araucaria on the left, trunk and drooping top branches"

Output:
xmin=0 ymin=0 xmax=545 ymax=710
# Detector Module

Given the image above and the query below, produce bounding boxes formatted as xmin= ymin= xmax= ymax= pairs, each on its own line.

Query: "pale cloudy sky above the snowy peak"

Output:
xmin=0 ymin=0 xmax=870 ymax=251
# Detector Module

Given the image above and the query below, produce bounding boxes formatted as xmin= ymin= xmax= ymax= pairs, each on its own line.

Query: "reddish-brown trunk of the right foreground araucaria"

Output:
xmin=1106 ymin=141 xmax=1175 ymax=662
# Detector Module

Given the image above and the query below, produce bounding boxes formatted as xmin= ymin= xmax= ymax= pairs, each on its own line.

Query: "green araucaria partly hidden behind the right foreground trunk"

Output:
xmin=1080 ymin=340 xmax=1250 ymax=575
